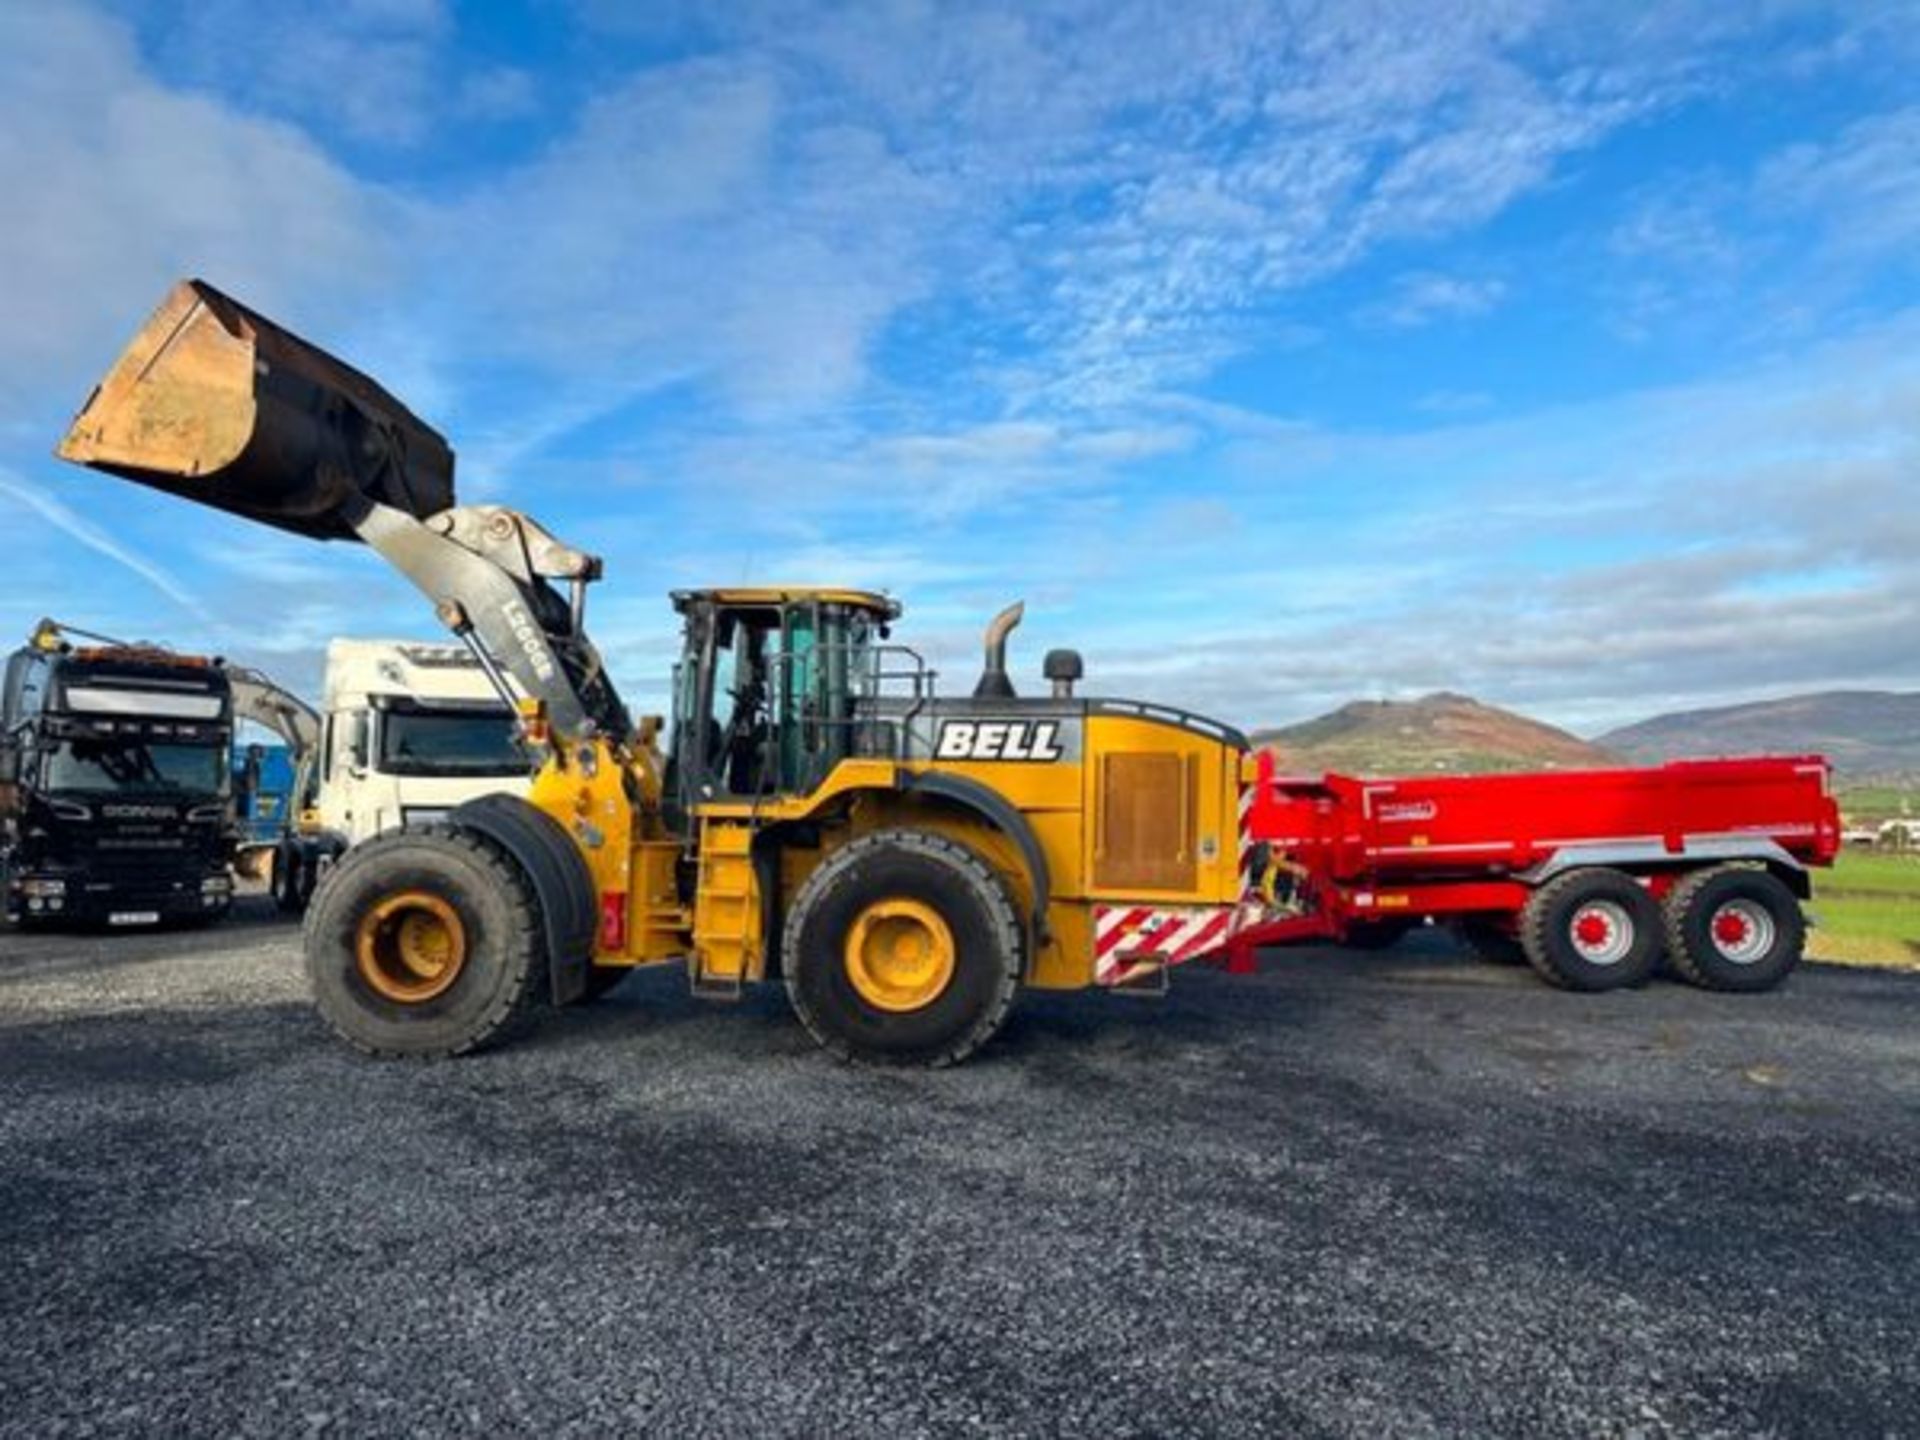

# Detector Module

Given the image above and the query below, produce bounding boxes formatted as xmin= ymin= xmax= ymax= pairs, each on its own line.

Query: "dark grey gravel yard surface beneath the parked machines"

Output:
xmin=0 ymin=912 xmax=1920 ymax=1436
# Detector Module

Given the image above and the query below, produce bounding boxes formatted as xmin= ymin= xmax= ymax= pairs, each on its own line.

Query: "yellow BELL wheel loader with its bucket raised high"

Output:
xmin=58 ymin=280 xmax=1271 ymax=1066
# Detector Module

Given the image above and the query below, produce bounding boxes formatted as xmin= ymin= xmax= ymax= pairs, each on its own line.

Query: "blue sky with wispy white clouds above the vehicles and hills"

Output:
xmin=0 ymin=0 xmax=1920 ymax=733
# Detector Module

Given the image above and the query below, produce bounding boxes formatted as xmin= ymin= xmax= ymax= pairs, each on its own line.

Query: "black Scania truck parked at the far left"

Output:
xmin=0 ymin=620 xmax=236 ymax=925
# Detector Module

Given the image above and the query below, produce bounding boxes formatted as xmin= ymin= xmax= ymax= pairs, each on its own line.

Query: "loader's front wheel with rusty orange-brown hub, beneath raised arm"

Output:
xmin=305 ymin=829 xmax=547 ymax=1056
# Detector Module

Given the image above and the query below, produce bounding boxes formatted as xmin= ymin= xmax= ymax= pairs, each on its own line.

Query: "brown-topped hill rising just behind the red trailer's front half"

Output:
xmin=1254 ymin=691 xmax=1619 ymax=776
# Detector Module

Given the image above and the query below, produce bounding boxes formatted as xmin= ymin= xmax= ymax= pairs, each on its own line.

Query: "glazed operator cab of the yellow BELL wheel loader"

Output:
xmin=666 ymin=588 xmax=900 ymax=818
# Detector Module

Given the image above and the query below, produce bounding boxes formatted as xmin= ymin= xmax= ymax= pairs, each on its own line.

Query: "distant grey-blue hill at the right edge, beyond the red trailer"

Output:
xmin=1596 ymin=689 xmax=1920 ymax=778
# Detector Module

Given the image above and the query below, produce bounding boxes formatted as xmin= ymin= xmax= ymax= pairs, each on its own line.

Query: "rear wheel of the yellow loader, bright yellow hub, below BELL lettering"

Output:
xmin=783 ymin=829 xmax=1023 ymax=1066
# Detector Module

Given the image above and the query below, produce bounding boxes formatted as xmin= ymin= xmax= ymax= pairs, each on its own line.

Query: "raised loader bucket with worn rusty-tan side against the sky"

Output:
xmin=54 ymin=280 xmax=453 ymax=540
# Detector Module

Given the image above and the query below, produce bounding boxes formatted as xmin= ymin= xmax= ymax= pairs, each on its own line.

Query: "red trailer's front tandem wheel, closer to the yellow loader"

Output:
xmin=1521 ymin=868 xmax=1661 ymax=991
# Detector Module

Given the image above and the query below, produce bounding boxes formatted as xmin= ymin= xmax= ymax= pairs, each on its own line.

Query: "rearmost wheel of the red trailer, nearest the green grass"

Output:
xmin=1665 ymin=866 xmax=1807 ymax=993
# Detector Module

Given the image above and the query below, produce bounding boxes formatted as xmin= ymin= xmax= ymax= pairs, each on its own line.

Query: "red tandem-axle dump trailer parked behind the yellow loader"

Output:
xmin=1227 ymin=755 xmax=1839 ymax=991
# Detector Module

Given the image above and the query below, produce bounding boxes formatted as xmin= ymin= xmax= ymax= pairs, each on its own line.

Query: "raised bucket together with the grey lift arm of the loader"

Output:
xmin=56 ymin=280 xmax=632 ymax=756
